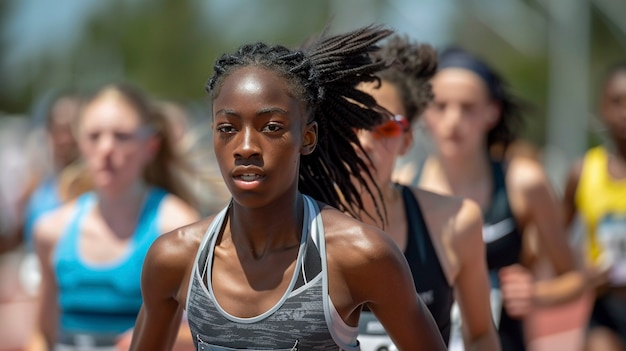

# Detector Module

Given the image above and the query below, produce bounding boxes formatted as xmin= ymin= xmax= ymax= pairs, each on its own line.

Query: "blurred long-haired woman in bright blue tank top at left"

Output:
xmin=31 ymin=84 xmax=198 ymax=351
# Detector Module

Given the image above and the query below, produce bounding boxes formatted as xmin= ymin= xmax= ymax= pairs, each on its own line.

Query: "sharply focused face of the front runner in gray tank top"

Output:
xmin=213 ymin=66 xmax=317 ymax=208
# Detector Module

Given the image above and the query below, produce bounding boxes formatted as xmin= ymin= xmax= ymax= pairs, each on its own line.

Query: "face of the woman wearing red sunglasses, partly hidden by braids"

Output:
xmin=357 ymin=81 xmax=413 ymax=186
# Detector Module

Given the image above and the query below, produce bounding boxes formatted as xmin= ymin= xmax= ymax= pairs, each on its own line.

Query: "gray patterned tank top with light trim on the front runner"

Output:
xmin=186 ymin=195 xmax=360 ymax=351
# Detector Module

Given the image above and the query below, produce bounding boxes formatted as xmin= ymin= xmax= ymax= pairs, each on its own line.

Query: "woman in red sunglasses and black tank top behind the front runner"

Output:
xmin=358 ymin=36 xmax=499 ymax=350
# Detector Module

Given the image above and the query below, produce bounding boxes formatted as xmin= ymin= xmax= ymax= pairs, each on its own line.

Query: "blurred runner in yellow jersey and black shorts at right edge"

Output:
xmin=564 ymin=62 xmax=626 ymax=351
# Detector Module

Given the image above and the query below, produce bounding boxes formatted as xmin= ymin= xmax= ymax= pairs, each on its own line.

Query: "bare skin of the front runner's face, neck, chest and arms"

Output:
xmin=131 ymin=66 xmax=445 ymax=350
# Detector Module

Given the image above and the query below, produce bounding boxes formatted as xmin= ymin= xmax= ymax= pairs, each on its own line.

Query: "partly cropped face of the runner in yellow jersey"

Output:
xmin=600 ymin=72 xmax=626 ymax=145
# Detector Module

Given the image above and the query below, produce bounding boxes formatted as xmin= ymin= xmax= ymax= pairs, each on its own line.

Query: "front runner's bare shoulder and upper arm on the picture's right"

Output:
xmin=324 ymin=210 xmax=445 ymax=350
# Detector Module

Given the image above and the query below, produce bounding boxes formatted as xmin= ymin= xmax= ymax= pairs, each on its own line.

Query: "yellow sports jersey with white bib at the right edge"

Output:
xmin=575 ymin=146 xmax=626 ymax=285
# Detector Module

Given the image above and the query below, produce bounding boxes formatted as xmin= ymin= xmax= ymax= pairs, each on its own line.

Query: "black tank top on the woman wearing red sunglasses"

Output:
xmin=398 ymin=184 xmax=454 ymax=345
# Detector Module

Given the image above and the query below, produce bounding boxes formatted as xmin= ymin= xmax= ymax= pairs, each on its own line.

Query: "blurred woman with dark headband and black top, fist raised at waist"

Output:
xmin=417 ymin=49 xmax=584 ymax=351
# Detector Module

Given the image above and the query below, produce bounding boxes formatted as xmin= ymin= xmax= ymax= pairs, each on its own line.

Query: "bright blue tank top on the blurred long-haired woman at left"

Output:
xmin=52 ymin=188 xmax=167 ymax=334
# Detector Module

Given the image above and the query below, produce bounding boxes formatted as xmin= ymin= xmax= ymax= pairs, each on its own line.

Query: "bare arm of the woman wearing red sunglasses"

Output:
xmin=453 ymin=200 xmax=500 ymax=351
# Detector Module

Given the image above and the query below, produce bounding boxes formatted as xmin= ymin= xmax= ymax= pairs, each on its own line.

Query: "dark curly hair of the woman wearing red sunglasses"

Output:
xmin=374 ymin=35 xmax=437 ymax=123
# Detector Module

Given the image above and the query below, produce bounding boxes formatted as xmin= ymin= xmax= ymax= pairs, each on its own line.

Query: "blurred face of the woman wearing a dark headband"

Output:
xmin=424 ymin=68 xmax=499 ymax=158
